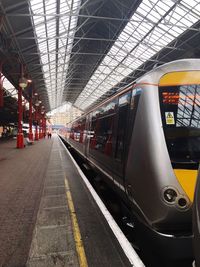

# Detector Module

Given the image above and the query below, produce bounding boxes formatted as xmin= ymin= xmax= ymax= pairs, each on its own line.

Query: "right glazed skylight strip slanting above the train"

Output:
xmin=75 ymin=0 xmax=200 ymax=110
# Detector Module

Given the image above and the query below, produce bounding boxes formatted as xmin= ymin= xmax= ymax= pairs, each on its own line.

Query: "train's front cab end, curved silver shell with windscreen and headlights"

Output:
xmin=126 ymin=59 xmax=200 ymax=266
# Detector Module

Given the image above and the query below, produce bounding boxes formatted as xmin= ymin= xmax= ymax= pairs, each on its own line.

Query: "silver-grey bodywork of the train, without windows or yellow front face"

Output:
xmin=63 ymin=59 xmax=200 ymax=262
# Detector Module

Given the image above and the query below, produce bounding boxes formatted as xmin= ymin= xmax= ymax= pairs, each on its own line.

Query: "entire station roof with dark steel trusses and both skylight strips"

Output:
xmin=0 ymin=0 xmax=200 ymax=111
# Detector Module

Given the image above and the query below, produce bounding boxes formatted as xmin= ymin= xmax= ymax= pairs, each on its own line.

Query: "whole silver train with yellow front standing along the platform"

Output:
xmin=60 ymin=59 xmax=200 ymax=266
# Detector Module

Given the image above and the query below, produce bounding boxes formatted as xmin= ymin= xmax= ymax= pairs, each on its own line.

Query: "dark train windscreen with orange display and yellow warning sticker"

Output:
xmin=159 ymin=84 xmax=200 ymax=169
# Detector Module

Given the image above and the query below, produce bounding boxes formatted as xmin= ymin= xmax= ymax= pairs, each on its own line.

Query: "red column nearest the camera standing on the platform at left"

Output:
xmin=17 ymin=87 xmax=24 ymax=148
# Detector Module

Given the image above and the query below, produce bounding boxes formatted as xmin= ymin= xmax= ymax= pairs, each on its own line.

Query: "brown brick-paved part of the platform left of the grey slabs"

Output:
xmin=0 ymin=137 xmax=53 ymax=267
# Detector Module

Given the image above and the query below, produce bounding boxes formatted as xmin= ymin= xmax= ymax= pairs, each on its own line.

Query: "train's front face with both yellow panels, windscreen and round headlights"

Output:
xmin=159 ymin=71 xmax=200 ymax=211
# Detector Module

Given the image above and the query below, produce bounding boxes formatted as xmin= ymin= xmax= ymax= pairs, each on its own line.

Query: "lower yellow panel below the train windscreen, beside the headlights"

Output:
xmin=174 ymin=169 xmax=197 ymax=202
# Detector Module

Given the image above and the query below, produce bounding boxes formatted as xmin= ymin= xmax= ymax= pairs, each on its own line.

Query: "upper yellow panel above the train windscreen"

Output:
xmin=159 ymin=71 xmax=200 ymax=86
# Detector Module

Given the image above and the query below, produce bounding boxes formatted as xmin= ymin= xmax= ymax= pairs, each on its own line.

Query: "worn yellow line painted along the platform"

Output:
xmin=65 ymin=176 xmax=88 ymax=267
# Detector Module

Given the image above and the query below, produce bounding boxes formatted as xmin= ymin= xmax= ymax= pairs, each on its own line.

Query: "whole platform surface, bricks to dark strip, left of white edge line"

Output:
xmin=0 ymin=136 xmax=143 ymax=267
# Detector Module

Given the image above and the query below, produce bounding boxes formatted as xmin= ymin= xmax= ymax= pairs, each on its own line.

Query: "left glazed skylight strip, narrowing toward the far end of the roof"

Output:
xmin=30 ymin=0 xmax=81 ymax=109
